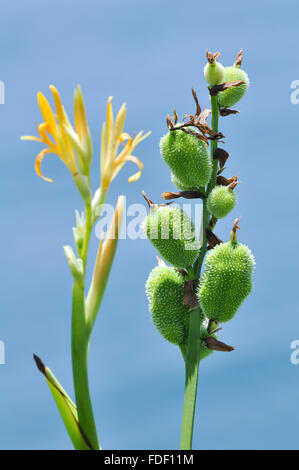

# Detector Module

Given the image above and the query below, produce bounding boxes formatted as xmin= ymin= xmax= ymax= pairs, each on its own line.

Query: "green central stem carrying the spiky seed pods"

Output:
xmin=180 ymin=96 xmax=219 ymax=450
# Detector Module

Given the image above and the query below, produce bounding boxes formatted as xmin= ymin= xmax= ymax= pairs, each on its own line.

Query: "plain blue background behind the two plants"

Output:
xmin=0 ymin=0 xmax=299 ymax=449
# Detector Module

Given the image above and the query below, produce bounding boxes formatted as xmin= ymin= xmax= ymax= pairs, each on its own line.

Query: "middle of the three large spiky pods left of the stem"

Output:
xmin=144 ymin=205 xmax=200 ymax=268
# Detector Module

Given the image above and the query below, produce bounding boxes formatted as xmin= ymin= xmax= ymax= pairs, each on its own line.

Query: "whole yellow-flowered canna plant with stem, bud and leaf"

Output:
xmin=22 ymin=85 xmax=149 ymax=450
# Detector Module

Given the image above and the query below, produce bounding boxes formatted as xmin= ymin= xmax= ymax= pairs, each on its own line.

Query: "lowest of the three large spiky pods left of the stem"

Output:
xmin=146 ymin=266 xmax=189 ymax=345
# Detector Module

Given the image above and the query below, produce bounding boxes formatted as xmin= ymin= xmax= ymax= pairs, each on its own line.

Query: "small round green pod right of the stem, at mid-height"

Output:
xmin=207 ymin=186 xmax=237 ymax=219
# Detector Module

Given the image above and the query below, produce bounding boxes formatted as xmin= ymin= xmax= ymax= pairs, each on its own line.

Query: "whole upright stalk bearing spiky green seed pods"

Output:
xmin=144 ymin=48 xmax=254 ymax=450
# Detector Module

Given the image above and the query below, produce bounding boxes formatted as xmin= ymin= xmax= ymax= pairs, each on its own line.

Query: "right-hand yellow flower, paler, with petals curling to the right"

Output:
xmin=101 ymin=96 xmax=150 ymax=191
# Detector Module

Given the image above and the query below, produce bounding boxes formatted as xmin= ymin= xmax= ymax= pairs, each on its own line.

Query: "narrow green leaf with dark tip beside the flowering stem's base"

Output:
xmin=33 ymin=354 xmax=92 ymax=450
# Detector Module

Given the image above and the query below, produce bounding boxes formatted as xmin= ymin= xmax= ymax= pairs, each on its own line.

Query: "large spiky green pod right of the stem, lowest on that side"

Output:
xmin=197 ymin=241 xmax=254 ymax=322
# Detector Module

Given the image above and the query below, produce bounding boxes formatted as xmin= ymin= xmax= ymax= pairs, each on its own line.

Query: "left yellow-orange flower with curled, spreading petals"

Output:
xmin=21 ymin=85 xmax=92 ymax=182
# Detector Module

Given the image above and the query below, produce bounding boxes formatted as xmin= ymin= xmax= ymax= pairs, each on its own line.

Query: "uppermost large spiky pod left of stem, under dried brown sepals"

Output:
xmin=160 ymin=130 xmax=212 ymax=188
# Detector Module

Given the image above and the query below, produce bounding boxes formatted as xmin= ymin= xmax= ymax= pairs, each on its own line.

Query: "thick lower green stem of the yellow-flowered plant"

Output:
xmin=72 ymin=281 xmax=99 ymax=449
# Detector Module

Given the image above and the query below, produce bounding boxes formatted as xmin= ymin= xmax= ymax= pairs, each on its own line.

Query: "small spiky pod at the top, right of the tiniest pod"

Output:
xmin=217 ymin=65 xmax=249 ymax=108
